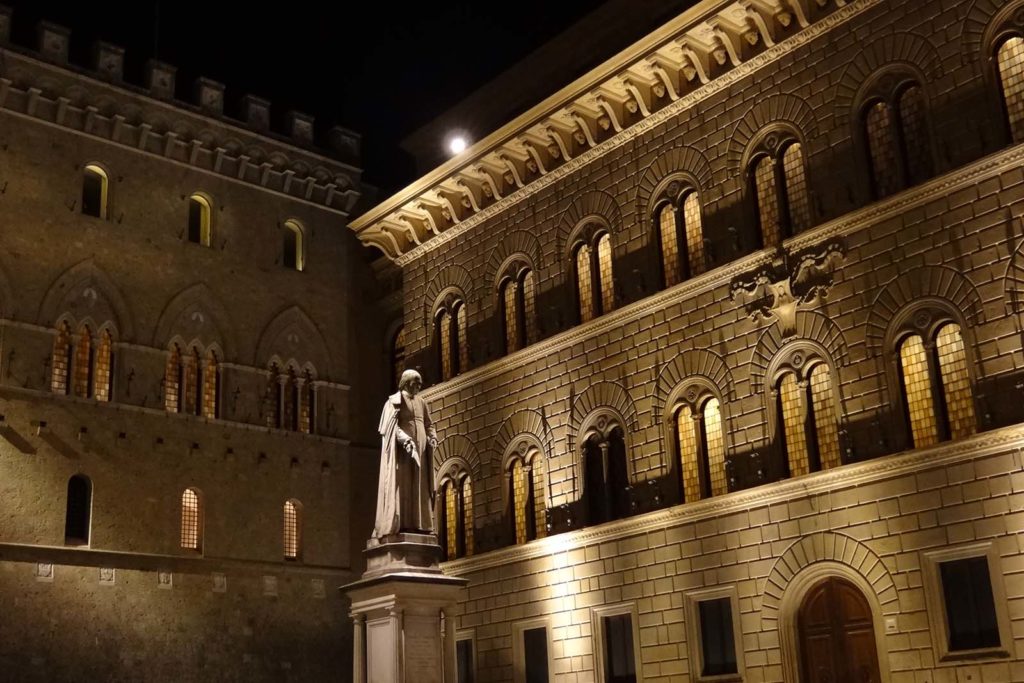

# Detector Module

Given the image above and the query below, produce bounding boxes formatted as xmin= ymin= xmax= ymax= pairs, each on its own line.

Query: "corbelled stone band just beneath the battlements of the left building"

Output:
xmin=0 ymin=48 xmax=359 ymax=217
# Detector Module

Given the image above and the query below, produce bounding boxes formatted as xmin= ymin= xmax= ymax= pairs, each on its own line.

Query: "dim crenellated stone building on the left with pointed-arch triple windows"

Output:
xmin=0 ymin=8 xmax=385 ymax=681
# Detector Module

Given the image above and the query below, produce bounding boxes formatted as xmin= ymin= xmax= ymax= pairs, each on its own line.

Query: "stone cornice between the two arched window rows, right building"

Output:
xmin=423 ymin=144 xmax=1024 ymax=400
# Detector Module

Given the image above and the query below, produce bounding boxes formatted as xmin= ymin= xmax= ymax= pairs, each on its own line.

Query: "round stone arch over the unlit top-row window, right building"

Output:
xmin=833 ymin=32 xmax=942 ymax=126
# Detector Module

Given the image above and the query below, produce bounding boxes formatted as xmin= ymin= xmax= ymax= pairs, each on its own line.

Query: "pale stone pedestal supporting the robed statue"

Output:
xmin=343 ymin=533 xmax=466 ymax=683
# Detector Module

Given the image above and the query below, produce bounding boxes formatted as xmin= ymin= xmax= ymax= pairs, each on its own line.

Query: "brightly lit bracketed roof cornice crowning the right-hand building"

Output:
xmin=350 ymin=0 xmax=878 ymax=263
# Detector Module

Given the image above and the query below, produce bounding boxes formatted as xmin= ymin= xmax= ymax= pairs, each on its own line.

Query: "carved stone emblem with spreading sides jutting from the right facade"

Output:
xmin=729 ymin=240 xmax=846 ymax=337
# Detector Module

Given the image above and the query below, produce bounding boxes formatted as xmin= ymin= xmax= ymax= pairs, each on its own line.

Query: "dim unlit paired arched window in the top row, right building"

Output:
xmin=862 ymin=79 xmax=932 ymax=199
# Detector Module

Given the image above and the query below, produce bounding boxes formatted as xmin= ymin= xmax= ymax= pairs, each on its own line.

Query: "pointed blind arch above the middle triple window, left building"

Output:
xmin=153 ymin=283 xmax=236 ymax=357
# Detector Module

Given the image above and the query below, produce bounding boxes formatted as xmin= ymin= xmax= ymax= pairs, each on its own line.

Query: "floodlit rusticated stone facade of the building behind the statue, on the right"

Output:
xmin=351 ymin=0 xmax=1024 ymax=683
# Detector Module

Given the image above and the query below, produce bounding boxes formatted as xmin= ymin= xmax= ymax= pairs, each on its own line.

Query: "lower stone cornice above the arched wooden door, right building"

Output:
xmin=443 ymin=425 xmax=1024 ymax=575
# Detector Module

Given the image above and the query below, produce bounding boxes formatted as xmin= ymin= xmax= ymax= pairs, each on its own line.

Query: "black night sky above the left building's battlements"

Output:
xmin=6 ymin=0 xmax=600 ymax=188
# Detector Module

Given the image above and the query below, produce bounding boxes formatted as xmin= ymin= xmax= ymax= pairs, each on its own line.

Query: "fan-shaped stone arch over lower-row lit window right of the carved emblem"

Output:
xmin=865 ymin=260 xmax=983 ymax=355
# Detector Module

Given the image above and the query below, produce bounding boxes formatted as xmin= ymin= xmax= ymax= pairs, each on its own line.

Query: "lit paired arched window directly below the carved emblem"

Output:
xmin=775 ymin=360 xmax=842 ymax=477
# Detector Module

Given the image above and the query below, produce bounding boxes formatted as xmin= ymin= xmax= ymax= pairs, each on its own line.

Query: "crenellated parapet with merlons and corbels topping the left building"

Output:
xmin=0 ymin=6 xmax=360 ymax=214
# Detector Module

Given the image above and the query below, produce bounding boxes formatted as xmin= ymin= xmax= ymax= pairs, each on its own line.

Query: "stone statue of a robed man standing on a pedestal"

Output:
xmin=374 ymin=370 xmax=437 ymax=539
